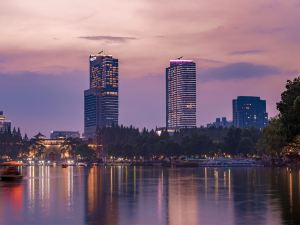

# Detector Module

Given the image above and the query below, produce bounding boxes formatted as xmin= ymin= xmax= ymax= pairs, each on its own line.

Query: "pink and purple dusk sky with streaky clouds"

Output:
xmin=0 ymin=0 xmax=300 ymax=136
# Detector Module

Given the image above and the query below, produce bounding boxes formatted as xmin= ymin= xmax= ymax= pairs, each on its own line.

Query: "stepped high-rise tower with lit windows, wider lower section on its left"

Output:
xmin=84 ymin=53 xmax=119 ymax=138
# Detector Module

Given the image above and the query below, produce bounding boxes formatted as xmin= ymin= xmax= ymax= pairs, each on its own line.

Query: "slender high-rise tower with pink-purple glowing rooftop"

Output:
xmin=166 ymin=59 xmax=196 ymax=130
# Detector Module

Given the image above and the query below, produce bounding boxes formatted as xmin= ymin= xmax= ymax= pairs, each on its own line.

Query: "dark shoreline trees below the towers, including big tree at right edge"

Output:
xmin=98 ymin=77 xmax=300 ymax=157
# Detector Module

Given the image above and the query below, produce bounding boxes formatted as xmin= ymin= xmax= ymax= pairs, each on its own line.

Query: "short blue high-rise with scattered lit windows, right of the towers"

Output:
xmin=232 ymin=96 xmax=268 ymax=129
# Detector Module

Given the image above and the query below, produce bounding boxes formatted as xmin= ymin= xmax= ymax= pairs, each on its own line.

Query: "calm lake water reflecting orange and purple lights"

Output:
xmin=0 ymin=166 xmax=300 ymax=225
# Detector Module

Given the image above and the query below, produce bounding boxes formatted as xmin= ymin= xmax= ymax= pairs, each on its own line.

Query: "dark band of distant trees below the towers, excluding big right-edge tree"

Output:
xmin=98 ymin=126 xmax=261 ymax=158
